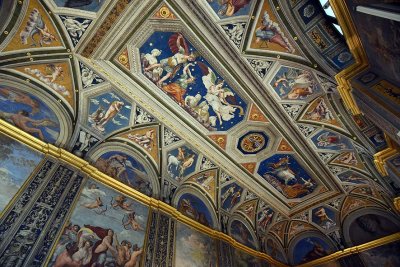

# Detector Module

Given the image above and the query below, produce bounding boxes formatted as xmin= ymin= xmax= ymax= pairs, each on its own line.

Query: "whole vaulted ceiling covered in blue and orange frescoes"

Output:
xmin=0 ymin=0 xmax=391 ymax=261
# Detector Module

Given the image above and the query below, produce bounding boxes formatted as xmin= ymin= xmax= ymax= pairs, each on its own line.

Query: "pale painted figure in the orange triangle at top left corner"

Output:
xmin=19 ymin=8 xmax=56 ymax=46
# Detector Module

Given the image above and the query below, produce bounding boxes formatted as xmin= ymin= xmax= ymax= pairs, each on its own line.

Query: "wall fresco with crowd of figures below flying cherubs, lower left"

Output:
xmin=49 ymin=180 xmax=149 ymax=267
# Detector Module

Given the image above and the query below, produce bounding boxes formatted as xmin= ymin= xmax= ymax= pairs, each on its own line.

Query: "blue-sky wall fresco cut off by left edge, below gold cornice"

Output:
xmin=0 ymin=134 xmax=43 ymax=214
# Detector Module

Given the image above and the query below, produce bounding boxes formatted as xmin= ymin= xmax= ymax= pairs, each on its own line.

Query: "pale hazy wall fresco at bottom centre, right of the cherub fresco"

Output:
xmin=174 ymin=223 xmax=217 ymax=267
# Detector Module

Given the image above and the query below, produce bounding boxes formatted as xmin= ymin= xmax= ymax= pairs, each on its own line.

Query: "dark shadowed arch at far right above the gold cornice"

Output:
xmin=343 ymin=207 xmax=400 ymax=246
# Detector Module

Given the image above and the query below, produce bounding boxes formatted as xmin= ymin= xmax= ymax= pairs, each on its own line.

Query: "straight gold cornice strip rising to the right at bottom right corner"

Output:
xmin=297 ymin=232 xmax=400 ymax=267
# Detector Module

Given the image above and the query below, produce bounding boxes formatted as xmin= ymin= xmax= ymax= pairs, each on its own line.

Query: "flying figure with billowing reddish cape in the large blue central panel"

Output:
xmin=144 ymin=33 xmax=197 ymax=87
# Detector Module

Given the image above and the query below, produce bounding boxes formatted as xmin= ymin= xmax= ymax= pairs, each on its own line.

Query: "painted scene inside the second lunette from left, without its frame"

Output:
xmin=94 ymin=151 xmax=153 ymax=196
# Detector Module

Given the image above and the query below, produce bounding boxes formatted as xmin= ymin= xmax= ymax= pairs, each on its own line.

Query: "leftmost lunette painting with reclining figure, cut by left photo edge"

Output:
xmin=0 ymin=85 xmax=60 ymax=143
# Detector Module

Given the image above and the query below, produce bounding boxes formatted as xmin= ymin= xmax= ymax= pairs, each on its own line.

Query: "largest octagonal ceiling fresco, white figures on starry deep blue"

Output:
xmin=140 ymin=32 xmax=247 ymax=131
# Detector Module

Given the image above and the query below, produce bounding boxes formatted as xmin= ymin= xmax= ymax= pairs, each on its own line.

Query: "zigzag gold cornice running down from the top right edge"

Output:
xmin=329 ymin=0 xmax=369 ymax=115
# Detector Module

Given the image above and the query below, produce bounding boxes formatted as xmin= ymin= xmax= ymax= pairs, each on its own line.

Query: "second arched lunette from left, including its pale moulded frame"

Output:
xmin=87 ymin=142 xmax=160 ymax=198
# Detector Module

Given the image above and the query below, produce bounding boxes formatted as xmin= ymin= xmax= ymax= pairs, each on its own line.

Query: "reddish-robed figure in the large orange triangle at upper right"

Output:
xmin=256 ymin=11 xmax=295 ymax=53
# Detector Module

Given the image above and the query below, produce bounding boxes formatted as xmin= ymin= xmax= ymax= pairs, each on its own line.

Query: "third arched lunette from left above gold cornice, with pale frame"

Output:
xmin=172 ymin=185 xmax=219 ymax=229
